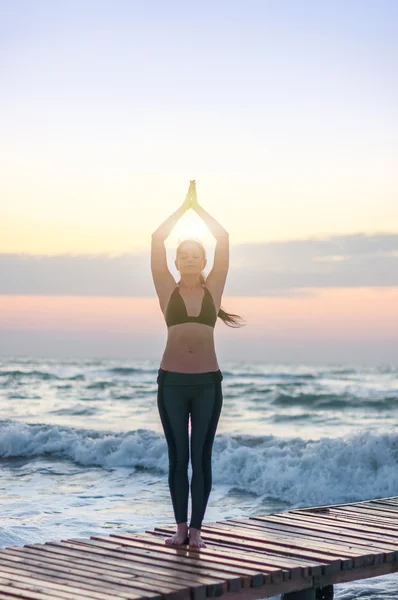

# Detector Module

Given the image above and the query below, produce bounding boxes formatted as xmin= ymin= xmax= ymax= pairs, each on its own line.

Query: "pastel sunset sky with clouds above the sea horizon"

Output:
xmin=0 ymin=0 xmax=398 ymax=368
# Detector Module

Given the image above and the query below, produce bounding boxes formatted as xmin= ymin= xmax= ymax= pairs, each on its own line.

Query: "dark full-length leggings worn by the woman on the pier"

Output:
xmin=157 ymin=368 xmax=223 ymax=529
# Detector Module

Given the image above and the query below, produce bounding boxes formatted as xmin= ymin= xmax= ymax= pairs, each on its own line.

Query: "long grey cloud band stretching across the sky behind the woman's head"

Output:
xmin=0 ymin=233 xmax=398 ymax=297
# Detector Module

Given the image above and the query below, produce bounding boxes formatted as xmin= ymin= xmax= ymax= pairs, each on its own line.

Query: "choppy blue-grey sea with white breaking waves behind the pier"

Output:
xmin=0 ymin=357 xmax=398 ymax=600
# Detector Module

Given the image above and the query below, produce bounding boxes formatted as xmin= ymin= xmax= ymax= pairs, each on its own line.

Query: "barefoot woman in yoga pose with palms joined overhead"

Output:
xmin=151 ymin=181 xmax=244 ymax=548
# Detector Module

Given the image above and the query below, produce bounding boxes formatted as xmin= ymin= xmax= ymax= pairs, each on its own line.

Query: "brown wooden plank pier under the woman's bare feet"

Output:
xmin=0 ymin=496 xmax=398 ymax=600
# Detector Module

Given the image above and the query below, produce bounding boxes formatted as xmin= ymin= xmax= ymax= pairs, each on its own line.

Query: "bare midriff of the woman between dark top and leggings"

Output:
xmin=160 ymin=323 xmax=220 ymax=373
